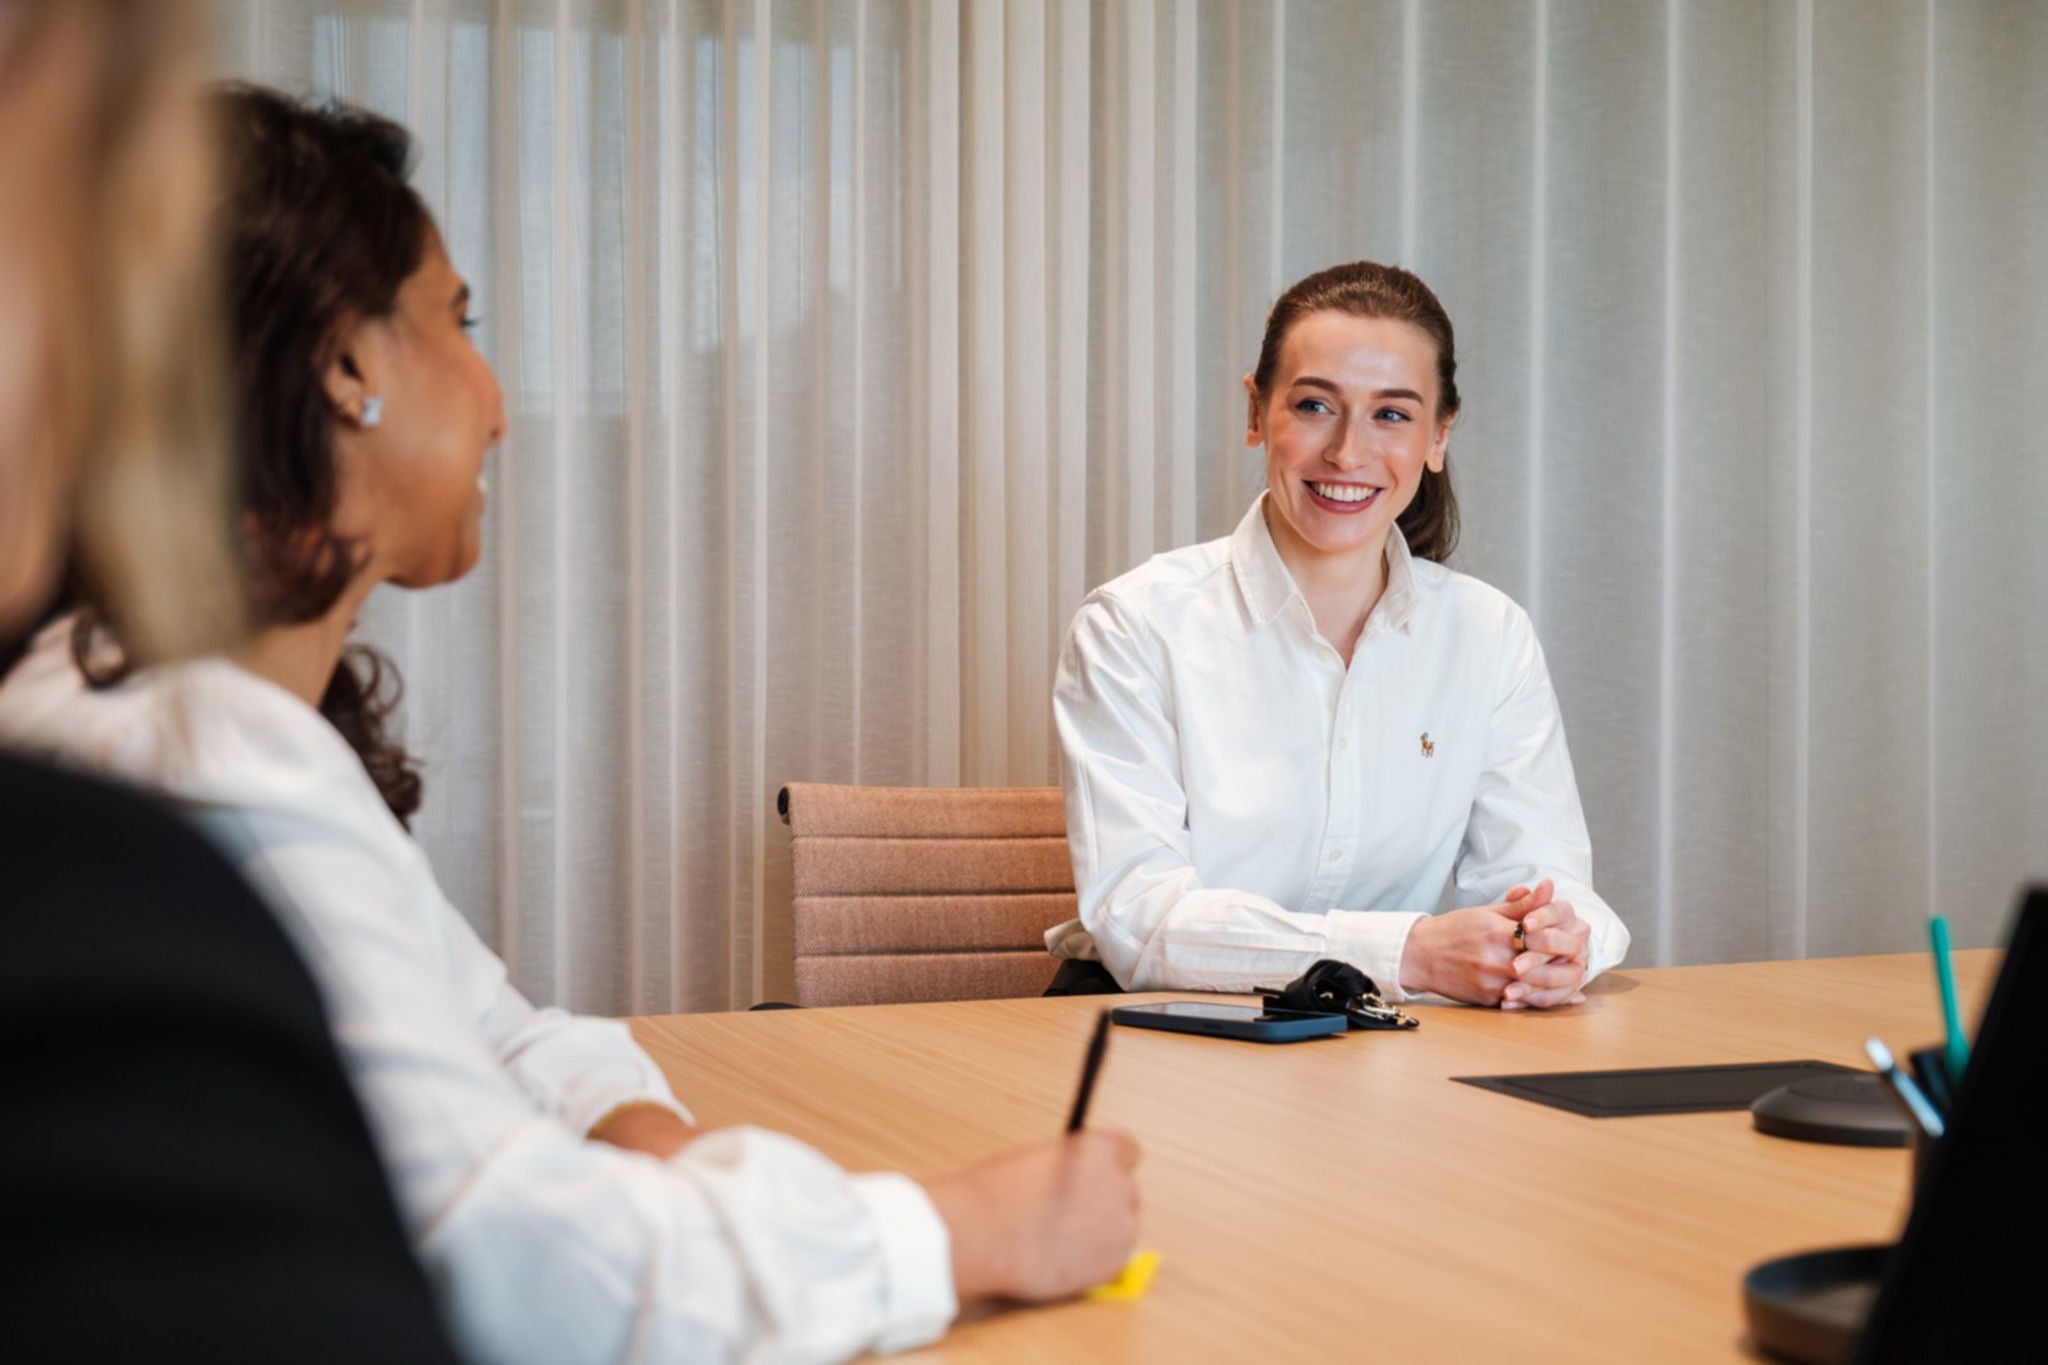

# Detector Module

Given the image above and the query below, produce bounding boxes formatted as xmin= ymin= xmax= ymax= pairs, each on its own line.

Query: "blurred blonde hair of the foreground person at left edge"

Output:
xmin=8 ymin=0 xmax=244 ymax=663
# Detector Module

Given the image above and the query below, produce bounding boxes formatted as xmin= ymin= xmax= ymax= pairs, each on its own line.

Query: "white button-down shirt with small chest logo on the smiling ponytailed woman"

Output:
xmin=1047 ymin=495 xmax=1628 ymax=999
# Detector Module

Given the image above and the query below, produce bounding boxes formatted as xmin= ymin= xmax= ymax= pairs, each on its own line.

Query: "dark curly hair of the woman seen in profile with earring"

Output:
xmin=72 ymin=84 xmax=432 ymax=825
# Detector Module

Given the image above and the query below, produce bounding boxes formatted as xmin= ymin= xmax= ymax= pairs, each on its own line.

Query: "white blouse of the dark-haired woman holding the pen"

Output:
xmin=0 ymin=620 xmax=954 ymax=1365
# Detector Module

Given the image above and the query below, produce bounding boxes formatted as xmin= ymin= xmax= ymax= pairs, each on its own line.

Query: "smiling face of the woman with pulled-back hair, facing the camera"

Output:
xmin=1245 ymin=313 xmax=1452 ymax=567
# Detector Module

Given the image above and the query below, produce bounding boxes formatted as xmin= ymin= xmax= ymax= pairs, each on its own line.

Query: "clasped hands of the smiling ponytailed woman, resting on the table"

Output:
xmin=1401 ymin=878 xmax=1593 ymax=1009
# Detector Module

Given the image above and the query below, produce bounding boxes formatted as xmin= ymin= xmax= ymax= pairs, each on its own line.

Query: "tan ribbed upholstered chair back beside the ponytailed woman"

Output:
xmin=776 ymin=782 xmax=1073 ymax=1007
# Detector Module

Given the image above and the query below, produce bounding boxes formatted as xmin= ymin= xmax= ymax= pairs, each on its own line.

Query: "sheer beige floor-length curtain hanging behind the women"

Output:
xmin=217 ymin=0 xmax=2048 ymax=1011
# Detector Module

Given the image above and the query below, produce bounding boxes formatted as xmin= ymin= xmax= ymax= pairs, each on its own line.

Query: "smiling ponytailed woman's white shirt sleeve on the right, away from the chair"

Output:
xmin=1456 ymin=610 xmax=1628 ymax=980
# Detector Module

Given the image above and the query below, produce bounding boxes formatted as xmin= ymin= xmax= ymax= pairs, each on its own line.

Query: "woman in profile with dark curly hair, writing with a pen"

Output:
xmin=0 ymin=88 xmax=1137 ymax=1363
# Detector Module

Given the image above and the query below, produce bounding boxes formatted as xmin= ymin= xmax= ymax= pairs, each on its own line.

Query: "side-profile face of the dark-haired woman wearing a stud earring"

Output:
xmin=328 ymin=233 xmax=506 ymax=587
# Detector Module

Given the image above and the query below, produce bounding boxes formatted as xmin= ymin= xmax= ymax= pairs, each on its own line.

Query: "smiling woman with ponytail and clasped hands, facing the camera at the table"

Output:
xmin=1047 ymin=262 xmax=1628 ymax=1009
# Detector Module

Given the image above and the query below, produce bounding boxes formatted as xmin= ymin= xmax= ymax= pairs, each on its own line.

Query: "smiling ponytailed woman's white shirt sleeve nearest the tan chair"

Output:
xmin=1053 ymin=591 xmax=1421 ymax=997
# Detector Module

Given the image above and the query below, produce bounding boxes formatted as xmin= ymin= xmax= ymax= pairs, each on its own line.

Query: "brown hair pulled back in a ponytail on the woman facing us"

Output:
xmin=1251 ymin=260 xmax=1458 ymax=563
